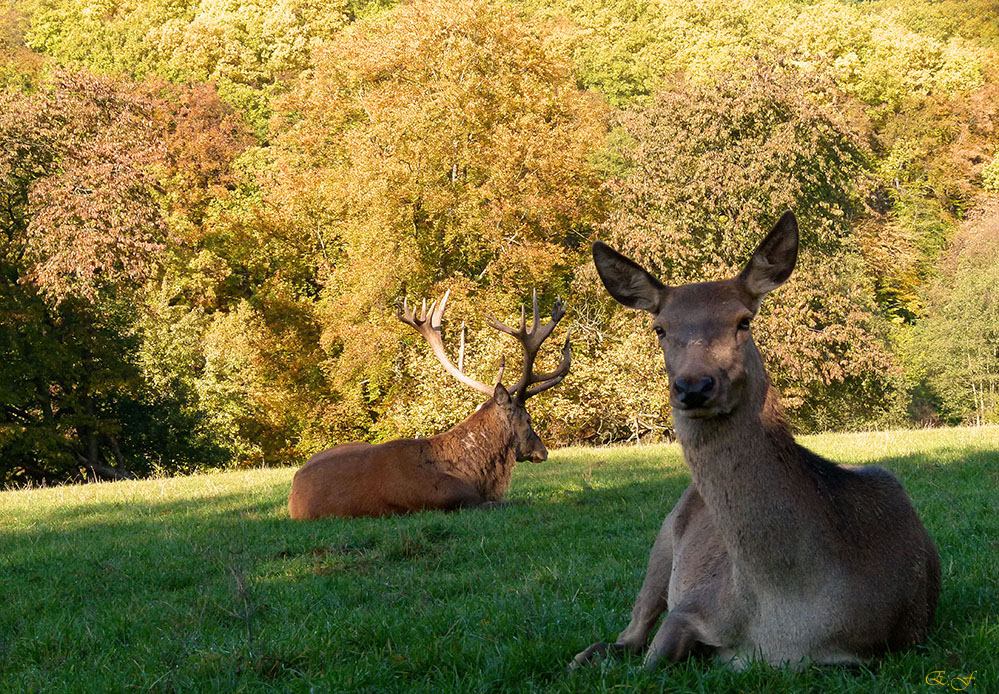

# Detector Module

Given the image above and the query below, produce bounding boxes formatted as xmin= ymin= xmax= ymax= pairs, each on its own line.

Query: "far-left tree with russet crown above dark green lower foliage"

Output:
xmin=0 ymin=72 xmax=246 ymax=482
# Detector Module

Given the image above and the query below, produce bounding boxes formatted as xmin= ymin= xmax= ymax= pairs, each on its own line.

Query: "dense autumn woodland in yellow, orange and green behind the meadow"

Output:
xmin=0 ymin=0 xmax=999 ymax=484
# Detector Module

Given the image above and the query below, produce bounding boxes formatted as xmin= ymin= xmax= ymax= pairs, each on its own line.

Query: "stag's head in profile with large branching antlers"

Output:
xmin=399 ymin=292 xmax=572 ymax=463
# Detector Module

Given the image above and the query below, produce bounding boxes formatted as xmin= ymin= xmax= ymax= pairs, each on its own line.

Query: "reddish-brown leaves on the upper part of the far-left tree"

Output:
xmin=6 ymin=72 xmax=254 ymax=301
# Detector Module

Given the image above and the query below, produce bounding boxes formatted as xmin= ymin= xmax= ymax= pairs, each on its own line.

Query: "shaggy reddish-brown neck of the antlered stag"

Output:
xmin=428 ymin=400 xmax=516 ymax=501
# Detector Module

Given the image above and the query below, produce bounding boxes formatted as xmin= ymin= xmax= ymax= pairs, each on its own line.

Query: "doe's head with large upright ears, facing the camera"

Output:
xmin=593 ymin=212 xmax=798 ymax=419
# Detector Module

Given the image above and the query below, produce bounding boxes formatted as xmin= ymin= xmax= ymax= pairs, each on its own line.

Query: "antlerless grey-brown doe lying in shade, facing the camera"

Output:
xmin=570 ymin=212 xmax=940 ymax=669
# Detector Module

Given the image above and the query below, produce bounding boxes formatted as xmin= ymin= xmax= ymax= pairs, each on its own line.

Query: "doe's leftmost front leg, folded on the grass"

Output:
xmin=569 ymin=509 xmax=676 ymax=669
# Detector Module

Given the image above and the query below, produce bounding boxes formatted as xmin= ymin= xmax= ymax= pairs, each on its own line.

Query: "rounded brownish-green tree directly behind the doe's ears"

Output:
xmin=604 ymin=61 xmax=897 ymax=436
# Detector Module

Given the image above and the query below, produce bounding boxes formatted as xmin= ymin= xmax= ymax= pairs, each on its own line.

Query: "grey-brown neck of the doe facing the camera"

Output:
xmin=675 ymin=362 xmax=822 ymax=586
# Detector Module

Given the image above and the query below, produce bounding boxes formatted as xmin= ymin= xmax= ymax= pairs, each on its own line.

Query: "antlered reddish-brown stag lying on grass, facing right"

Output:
xmin=288 ymin=293 xmax=572 ymax=519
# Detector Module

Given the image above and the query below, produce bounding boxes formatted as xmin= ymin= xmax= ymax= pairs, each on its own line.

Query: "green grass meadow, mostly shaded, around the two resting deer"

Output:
xmin=0 ymin=428 xmax=999 ymax=694
